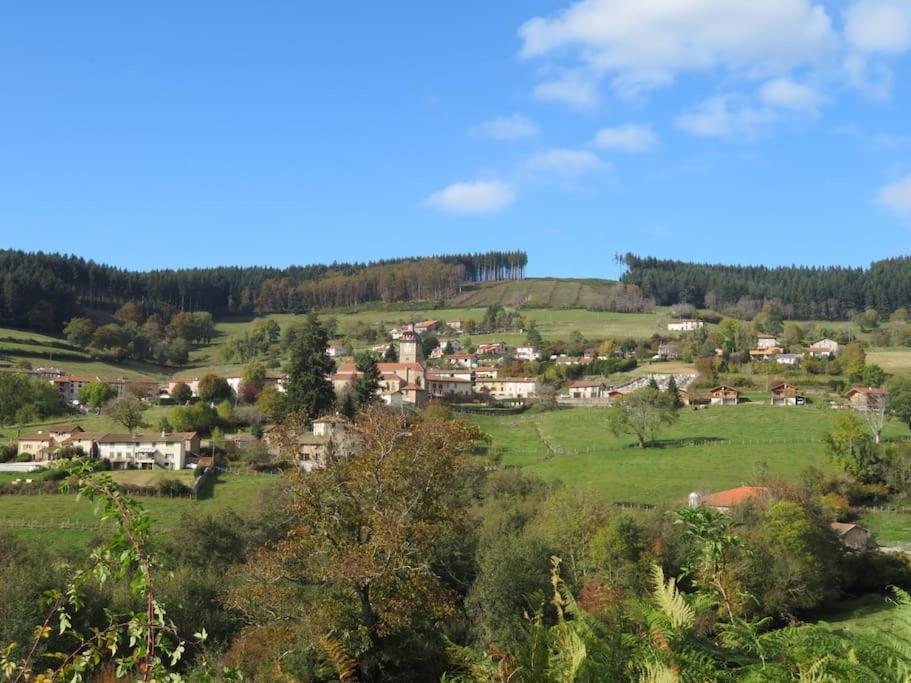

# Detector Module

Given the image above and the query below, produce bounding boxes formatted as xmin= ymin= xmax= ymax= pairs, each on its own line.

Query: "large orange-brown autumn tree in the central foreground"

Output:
xmin=229 ymin=406 xmax=482 ymax=682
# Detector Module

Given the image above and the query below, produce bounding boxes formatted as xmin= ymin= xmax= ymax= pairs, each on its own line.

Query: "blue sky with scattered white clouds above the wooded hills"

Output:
xmin=0 ymin=0 xmax=911 ymax=277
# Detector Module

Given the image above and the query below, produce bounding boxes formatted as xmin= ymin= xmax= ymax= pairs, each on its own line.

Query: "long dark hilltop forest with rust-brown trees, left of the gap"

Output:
xmin=0 ymin=250 xmax=528 ymax=331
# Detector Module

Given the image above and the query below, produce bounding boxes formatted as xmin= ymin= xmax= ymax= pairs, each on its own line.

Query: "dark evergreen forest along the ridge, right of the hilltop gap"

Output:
xmin=622 ymin=254 xmax=911 ymax=320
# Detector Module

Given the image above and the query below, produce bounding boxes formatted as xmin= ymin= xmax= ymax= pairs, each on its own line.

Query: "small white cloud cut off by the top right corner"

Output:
xmin=845 ymin=0 xmax=911 ymax=54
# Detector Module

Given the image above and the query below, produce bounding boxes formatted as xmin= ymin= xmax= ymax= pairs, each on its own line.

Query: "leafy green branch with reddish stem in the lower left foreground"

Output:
xmin=0 ymin=460 xmax=231 ymax=683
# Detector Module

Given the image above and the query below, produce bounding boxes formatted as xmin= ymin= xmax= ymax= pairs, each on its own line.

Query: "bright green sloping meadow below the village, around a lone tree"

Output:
xmin=472 ymin=404 xmax=909 ymax=503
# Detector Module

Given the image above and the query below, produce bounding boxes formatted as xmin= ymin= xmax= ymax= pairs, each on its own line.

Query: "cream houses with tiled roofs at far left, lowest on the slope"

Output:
xmin=18 ymin=425 xmax=200 ymax=470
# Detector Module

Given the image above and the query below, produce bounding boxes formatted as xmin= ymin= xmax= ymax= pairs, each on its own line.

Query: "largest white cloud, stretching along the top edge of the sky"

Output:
xmin=519 ymin=0 xmax=838 ymax=96
